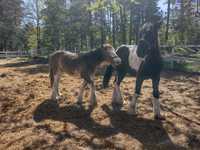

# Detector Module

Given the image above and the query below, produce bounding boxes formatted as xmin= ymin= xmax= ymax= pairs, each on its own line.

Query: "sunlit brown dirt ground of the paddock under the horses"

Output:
xmin=0 ymin=59 xmax=200 ymax=150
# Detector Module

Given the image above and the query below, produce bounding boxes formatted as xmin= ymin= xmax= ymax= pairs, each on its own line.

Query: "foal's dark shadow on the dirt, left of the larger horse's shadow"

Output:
xmin=33 ymin=99 xmax=116 ymax=137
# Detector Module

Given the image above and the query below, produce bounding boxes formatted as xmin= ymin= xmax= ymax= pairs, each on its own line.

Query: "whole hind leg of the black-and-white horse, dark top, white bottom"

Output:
xmin=112 ymin=71 xmax=126 ymax=106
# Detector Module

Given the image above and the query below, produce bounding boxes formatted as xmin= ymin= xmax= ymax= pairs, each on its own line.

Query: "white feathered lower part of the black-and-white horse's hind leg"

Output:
xmin=112 ymin=83 xmax=123 ymax=104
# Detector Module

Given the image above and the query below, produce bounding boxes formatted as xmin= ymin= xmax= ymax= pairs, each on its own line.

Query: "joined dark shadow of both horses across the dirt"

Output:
xmin=33 ymin=100 xmax=188 ymax=149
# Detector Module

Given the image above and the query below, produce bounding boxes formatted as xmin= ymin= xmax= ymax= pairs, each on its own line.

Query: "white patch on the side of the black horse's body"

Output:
xmin=128 ymin=45 xmax=144 ymax=71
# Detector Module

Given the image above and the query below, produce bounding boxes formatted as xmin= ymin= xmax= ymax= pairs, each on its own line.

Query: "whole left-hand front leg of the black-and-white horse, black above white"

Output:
xmin=128 ymin=76 xmax=144 ymax=115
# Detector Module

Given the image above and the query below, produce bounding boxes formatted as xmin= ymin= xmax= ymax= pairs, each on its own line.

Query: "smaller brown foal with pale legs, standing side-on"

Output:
xmin=49 ymin=44 xmax=121 ymax=106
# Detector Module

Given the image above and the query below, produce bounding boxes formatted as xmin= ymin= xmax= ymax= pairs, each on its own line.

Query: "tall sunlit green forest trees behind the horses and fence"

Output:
xmin=0 ymin=0 xmax=200 ymax=53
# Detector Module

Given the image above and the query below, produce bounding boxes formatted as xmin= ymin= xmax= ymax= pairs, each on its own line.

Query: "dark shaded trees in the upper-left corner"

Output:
xmin=0 ymin=0 xmax=22 ymax=50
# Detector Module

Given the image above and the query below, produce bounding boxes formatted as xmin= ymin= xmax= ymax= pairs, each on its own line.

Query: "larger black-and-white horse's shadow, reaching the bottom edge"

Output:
xmin=102 ymin=105 xmax=188 ymax=149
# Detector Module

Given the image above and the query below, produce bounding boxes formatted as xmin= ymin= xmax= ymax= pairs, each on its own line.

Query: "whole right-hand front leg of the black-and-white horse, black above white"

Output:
xmin=152 ymin=77 xmax=164 ymax=120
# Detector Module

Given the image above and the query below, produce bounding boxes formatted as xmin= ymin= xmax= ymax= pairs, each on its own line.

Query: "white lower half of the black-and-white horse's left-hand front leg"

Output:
xmin=128 ymin=94 xmax=139 ymax=115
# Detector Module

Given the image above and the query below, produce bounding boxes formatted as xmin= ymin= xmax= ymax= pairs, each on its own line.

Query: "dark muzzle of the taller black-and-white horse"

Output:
xmin=137 ymin=40 xmax=149 ymax=58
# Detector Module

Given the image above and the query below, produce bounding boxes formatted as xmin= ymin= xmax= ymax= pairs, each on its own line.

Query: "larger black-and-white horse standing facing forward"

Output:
xmin=103 ymin=23 xmax=162 ymax=119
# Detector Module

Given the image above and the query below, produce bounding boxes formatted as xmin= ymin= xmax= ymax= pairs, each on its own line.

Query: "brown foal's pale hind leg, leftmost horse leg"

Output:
xmin=51 ymin=73 xmax=60 ymax=100
